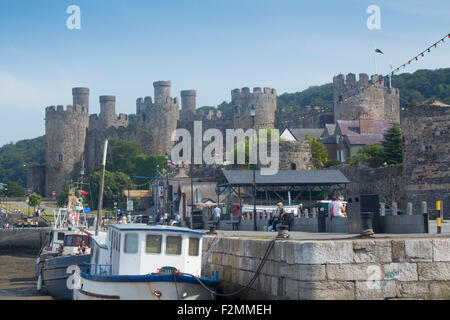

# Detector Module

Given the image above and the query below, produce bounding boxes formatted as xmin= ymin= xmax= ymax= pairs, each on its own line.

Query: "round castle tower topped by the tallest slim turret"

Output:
xmin=136 ymin=81 xmax=179 ymax=155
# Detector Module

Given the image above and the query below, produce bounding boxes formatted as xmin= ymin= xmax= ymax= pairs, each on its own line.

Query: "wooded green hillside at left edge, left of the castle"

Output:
xmin=0 ymin=136 xmax=45 ymax=186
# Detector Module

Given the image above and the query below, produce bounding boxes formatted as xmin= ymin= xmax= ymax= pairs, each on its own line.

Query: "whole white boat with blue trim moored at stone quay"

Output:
xmin=73 ymin=223 xmax=219 ymax=300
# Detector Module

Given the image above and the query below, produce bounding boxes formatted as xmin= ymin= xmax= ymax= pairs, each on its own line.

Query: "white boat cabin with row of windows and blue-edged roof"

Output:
xmin=91 ymin=223 xmax=203 ymax=276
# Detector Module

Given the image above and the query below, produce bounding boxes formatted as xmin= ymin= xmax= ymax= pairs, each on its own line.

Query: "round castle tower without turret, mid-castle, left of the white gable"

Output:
xmin=231 ymin=87 xmax=277 ymax=129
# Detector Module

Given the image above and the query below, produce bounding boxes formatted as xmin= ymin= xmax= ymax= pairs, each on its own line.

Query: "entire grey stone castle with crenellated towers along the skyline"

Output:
xmin=37 ymin=74 xmax=400 ymax=196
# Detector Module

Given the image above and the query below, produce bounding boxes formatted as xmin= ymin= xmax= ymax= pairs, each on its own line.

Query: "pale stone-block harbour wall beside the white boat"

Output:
xmin=203 ymin=237 xmax=450 ymax=300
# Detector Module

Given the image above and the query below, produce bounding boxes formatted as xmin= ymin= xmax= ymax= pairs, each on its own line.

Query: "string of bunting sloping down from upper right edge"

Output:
xmin=268 ymin=33 xmax=450 ymax=126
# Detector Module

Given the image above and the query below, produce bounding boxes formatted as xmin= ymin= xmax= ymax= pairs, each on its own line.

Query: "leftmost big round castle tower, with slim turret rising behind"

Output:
xmin=45 ymin=101 xmax=89 ymax=197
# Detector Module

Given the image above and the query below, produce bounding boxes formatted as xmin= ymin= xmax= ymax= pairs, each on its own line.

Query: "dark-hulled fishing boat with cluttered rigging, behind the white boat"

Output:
xmin=36 ymin=187 xmax=90 ymax=299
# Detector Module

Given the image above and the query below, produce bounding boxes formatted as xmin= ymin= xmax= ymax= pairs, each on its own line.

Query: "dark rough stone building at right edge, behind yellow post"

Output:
xmin=401 ymin=100 xmax=450 ymax=218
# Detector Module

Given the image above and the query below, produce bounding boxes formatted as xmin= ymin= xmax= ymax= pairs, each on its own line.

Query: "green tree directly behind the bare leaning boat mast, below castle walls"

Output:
xmin=89 ymin=170 xmax=130 ymax=209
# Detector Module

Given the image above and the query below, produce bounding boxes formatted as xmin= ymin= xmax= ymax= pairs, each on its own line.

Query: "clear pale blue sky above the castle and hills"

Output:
xmin=0 ymin=0 xmax=450 ymax=145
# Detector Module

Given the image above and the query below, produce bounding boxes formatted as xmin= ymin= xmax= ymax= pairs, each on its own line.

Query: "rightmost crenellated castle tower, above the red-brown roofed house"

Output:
xmin=333 ymin=73 xmax=400 ymax=123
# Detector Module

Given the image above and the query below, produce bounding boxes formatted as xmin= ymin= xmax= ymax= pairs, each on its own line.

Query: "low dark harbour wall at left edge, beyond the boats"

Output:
xmin=0 ymin=228 xmax=50 ymax=254
